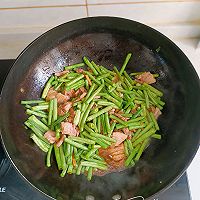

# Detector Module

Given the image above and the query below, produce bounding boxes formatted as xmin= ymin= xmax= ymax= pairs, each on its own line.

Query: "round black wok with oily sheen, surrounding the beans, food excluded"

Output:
xmin=0 ymin=17 xmax=200 ymax=200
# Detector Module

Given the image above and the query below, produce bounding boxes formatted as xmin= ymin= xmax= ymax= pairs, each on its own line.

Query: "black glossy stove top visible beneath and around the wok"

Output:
xmin=0 ymin=60 xmax=191 ymax=200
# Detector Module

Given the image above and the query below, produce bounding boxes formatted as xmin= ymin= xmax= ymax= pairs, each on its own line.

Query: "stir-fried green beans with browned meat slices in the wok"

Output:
xmin=21 ymin=53 xmax=165 ymax=180
